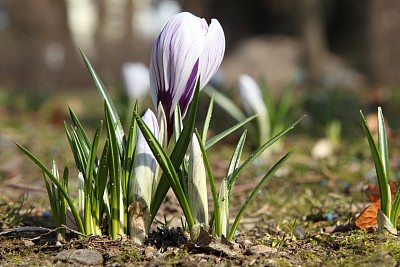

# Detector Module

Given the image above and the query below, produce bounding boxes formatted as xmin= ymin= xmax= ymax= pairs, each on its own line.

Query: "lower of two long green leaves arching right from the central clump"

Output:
xmin=228 ymin=148 xmax=295 ymax=242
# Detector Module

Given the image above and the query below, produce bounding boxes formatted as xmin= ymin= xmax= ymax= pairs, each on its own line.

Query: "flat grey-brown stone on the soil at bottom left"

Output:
xmin=55 ymin=249 xmax=103 ymax=265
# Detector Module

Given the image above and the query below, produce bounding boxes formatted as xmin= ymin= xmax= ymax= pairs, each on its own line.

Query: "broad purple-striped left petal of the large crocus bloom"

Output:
xmin=150 ymin=12 xmax=204 ymax=117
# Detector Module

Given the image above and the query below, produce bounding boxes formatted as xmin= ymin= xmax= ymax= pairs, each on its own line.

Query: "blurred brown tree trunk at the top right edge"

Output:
xmin=369 ymin=0 xmax=400 ymax=86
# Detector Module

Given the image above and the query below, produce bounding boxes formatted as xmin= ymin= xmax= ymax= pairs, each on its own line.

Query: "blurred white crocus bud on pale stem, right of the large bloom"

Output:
xmin=238 ymin=74 xmax=270 ymax=147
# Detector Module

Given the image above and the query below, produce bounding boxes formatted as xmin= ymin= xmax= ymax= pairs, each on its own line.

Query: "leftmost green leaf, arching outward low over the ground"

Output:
xmin=16 ymin=143 xmax=85 ymax=234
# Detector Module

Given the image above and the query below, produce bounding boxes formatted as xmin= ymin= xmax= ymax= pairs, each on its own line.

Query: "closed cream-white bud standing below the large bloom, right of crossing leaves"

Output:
xmin=187 ymin=134 xmax=208 ymax=225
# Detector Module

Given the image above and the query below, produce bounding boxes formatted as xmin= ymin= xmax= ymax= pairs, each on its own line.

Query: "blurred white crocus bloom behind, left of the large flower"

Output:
xmin=122 ymin=62 xmax=150 ymax=100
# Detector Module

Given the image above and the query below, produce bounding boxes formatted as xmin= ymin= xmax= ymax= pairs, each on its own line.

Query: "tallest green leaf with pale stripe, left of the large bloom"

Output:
xmin=79 ymin=50 xmax=125 ymax=158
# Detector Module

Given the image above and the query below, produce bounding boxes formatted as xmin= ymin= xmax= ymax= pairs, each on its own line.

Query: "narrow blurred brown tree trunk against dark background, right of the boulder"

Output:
xmin=297 ymin=0 xmax=327 ymax=83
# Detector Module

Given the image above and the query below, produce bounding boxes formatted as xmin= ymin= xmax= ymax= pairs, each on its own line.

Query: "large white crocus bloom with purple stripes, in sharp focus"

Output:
xmin=150 ymin=12 xmax=225 ymax=133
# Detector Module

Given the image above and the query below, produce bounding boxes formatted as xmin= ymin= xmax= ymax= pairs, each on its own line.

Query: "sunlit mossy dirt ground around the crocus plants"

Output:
xmin=0 ymin=89 xmax=400 ymax=266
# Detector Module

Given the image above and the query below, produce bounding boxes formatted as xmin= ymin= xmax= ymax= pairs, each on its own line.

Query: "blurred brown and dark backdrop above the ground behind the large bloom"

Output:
xmin=0 ymin=0 xmax=400 ymax=90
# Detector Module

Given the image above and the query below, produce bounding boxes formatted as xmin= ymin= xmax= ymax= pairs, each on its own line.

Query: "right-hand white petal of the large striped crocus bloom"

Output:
xmin=200 ymin=19 xmax=225 ymax=88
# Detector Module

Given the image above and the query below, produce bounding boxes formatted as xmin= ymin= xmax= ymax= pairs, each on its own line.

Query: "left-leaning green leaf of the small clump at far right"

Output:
xmin=360 ymin=110 xmax=391 ymax=218
